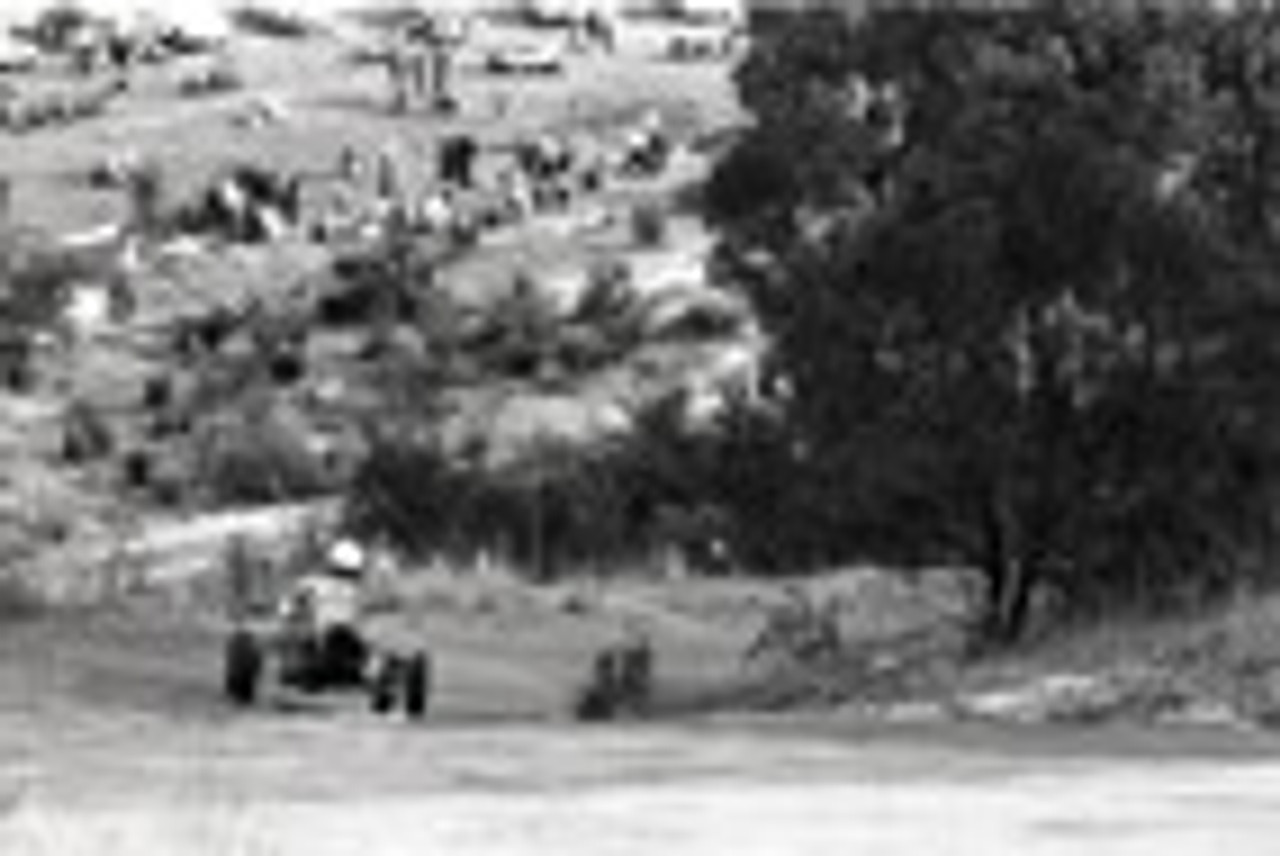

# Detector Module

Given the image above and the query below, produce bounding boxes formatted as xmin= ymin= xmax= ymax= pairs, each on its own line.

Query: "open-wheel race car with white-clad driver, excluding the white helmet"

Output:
xmin=223 ymin=537 xmax=433 ymax=719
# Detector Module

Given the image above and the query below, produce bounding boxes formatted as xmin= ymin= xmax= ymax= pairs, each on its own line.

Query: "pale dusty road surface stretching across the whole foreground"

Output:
xmin=0 ymin=711 xmax=1280 ymax=856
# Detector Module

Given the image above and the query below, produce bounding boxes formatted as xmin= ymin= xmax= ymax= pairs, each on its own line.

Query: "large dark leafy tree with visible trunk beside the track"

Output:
xmin=708 ymin=0 xmax=1280 ymax=642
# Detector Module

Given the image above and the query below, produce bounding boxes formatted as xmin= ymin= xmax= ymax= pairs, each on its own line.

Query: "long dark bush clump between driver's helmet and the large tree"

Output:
xmin=347 ymin=386 xmax=803 ymax=576
